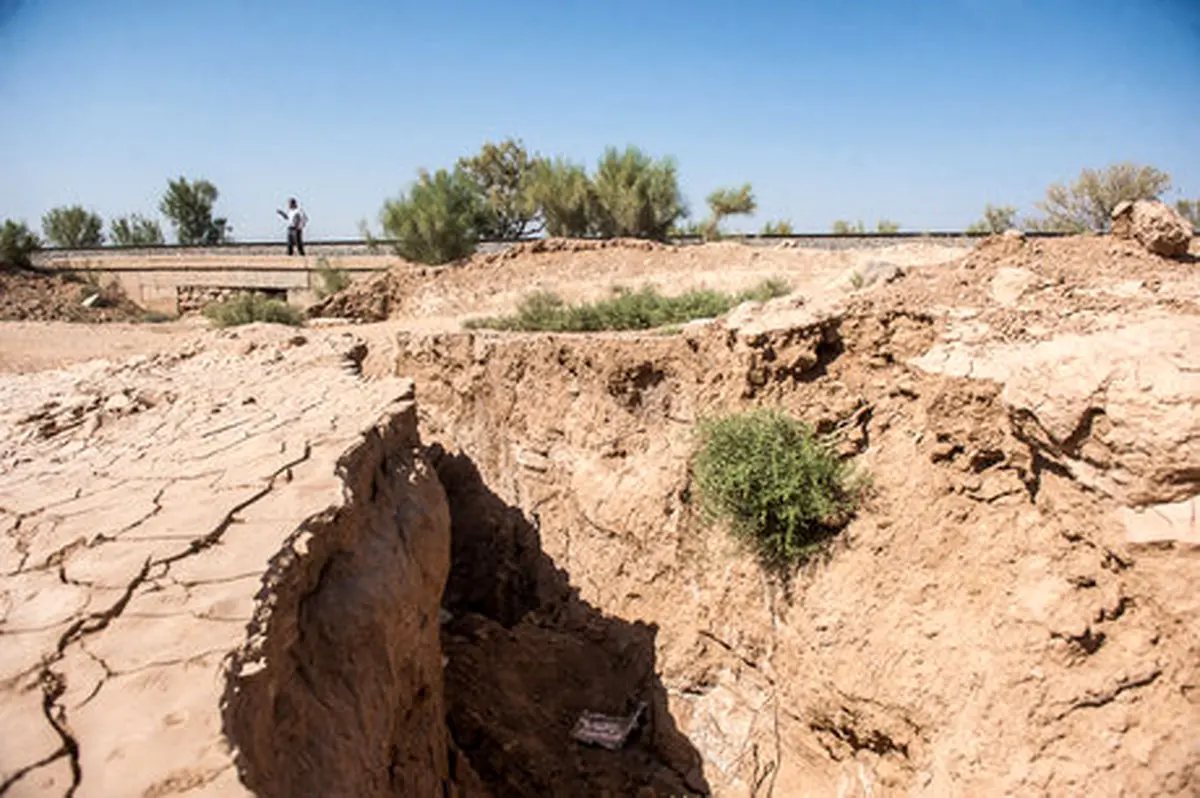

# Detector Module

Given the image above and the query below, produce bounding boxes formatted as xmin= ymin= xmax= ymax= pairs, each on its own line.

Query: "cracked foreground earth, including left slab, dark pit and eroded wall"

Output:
xmin=0 ymin=238 xmax=1200 ymax=798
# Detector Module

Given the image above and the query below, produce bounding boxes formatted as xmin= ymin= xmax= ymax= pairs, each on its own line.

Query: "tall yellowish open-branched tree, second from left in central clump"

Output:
xmin=458 ymin=138 xmax=538 ymax=241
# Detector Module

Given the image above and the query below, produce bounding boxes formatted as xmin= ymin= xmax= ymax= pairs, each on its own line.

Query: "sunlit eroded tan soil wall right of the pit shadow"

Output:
xmin=394 ymin=239 xmax=1200 ymax=796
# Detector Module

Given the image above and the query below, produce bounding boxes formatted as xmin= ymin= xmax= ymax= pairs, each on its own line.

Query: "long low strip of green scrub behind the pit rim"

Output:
xmin=464 ymin=278 xmax=791 ymax=332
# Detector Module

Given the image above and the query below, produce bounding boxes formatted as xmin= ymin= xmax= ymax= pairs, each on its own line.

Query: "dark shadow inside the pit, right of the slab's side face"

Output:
xmin=427 ymin=446 xmax=710 ymax=798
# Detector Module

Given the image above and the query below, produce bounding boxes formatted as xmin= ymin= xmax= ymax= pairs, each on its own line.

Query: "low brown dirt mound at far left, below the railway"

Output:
xmin=0 ymin=270 xmax=144 ymax=322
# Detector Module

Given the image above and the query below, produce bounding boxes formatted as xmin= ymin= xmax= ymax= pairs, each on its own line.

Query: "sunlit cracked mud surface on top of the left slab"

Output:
xmin=0 ymin=330 xmax=424 ymax=796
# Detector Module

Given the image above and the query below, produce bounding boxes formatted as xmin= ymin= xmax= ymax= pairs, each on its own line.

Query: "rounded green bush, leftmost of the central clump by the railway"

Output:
xmin=379 ymin=169 xmax=482 ymax=264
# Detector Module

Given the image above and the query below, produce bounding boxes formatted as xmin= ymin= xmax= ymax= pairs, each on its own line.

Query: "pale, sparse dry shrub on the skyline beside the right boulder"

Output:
xmin=1031 ymin=162 xmax=1171 ymax=233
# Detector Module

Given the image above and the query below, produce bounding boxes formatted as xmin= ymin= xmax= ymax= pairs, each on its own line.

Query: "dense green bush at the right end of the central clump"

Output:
xmin=593 ymin=146 xmax=688 ymax=240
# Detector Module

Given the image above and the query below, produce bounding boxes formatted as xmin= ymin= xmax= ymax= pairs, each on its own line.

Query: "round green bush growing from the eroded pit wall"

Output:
xmin=692 ymin=409 xmax=863 ymax=568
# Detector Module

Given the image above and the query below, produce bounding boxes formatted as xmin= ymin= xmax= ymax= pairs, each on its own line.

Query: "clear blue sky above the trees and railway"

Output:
xmin=0 ymin=0 xmax=1200 ymax=240
